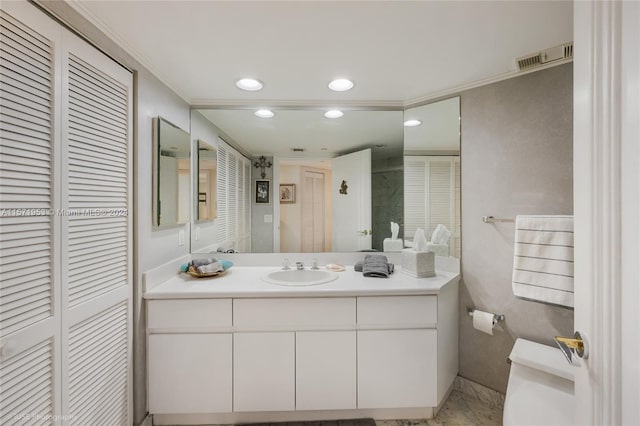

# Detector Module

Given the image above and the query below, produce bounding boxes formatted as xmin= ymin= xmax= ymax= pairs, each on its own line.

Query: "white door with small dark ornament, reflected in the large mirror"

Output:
xmin=331 ymin=149 xmax=371 ymax=251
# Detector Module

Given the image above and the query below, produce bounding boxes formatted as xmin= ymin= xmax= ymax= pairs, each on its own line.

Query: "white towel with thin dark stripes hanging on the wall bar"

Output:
xmin=512 ymin=216 xmax=573 ymax=308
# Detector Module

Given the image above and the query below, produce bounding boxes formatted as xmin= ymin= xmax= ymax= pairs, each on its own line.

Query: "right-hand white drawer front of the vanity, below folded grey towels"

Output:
xmin=358 ymin=296 xmax=438 ymax=328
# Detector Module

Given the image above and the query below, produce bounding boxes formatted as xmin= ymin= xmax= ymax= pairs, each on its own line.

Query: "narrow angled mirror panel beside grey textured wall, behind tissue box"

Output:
xmin=404 ymin=97 xmax=461 ymax=258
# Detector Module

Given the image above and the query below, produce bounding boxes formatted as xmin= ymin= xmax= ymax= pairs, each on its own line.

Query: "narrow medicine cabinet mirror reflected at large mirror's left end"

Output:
xmin=194 ymin=139 xmax=218 ymax=223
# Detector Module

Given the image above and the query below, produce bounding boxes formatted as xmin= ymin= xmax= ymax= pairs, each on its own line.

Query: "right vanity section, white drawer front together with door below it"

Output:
xmin=357 ymin=295 xmax=438 ymax=408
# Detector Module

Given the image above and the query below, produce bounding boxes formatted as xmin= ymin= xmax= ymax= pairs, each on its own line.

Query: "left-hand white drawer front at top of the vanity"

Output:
xmin=147 ymin=299 xmax=232 ymax=329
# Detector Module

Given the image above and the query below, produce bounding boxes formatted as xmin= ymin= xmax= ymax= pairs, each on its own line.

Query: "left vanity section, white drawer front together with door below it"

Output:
xmin=147 ymin=299 xmax=233 ymax=413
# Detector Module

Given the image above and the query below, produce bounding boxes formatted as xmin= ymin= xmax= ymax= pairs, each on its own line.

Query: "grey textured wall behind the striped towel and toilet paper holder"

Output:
xmin=460 ymin=64 xmax=573 ymax=392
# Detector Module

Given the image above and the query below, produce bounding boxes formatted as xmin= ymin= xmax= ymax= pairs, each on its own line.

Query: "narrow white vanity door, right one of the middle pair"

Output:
xmin=296 ymin=331 xmax=356 ymax=410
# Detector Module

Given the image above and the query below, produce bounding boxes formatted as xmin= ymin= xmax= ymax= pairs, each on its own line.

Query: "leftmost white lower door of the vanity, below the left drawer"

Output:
xmin=149 ymin=334 xmax=232 ymax=414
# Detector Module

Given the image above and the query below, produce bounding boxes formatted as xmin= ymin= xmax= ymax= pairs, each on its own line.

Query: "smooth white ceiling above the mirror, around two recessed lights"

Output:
xmin=70 ymin=0 xmax=573 ymax=105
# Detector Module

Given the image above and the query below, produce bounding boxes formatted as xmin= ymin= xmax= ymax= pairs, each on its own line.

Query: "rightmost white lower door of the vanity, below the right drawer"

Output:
xmin=358 ymin=329 xmax=437 ymax=408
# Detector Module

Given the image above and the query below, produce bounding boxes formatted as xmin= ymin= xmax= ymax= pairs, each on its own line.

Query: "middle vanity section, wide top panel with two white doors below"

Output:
xmin=233 ymin=297 xmax=356 ymax=411
